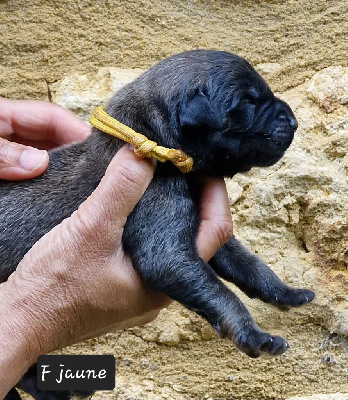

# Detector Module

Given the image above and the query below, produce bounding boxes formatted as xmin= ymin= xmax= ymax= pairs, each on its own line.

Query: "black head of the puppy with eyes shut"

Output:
xmin=139 ymin=50 xmax=297 ymax=176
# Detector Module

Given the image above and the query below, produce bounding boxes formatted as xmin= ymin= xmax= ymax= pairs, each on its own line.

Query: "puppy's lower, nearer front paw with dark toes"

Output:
xmin=235 ymin=330 xmax=289 ymax=358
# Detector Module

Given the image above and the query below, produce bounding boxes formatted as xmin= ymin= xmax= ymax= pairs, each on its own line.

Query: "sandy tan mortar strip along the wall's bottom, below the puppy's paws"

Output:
xmin=62 ymin=323 xmax=348 ymax=400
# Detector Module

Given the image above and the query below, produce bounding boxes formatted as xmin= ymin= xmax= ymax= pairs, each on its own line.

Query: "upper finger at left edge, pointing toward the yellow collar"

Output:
xmin=0 ymin=98 xmax=90 ymax=145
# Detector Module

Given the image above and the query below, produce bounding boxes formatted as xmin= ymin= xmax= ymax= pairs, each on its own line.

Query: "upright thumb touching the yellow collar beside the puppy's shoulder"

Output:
xmin=78 ymin=146 xmax=155 ymax=231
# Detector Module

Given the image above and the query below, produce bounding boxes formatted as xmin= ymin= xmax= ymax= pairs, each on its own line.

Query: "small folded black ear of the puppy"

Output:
xmin=180 ymin=88 xmax=223 ymax=129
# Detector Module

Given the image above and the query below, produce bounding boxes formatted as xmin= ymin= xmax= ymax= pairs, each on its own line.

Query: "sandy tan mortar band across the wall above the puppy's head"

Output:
xmin=0 ymin=0 xmax=348 ymax=98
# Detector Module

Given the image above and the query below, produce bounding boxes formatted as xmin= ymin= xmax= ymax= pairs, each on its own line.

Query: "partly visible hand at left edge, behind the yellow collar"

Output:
xmin=0 ymin=97 xmax=90 ymax=180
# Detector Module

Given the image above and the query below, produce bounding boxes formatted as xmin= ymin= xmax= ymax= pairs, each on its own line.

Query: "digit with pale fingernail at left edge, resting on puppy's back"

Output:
xmin=0 ymin=138 xmax=48 ymax=180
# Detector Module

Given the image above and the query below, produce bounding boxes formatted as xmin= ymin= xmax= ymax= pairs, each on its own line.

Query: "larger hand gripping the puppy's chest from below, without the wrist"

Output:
xmin=0 ymin=147 xmax=231 ymax=344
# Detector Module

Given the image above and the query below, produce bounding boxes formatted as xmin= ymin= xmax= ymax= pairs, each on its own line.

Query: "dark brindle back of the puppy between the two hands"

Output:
xmin=0 ymin=139 xmax=105 ymax=282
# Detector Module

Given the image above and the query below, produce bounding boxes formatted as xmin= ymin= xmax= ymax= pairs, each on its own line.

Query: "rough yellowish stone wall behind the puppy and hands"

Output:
xmin=0 ymin=0 xmax=348 ymax=400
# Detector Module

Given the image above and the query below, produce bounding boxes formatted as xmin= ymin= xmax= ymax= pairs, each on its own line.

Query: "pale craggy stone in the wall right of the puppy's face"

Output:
xmin=227 ymin=67 xmax=348 ymax=335
